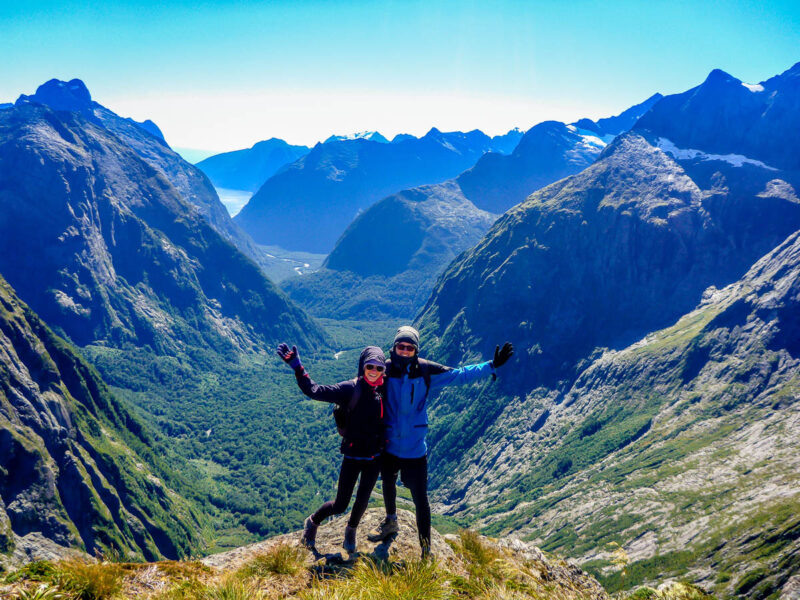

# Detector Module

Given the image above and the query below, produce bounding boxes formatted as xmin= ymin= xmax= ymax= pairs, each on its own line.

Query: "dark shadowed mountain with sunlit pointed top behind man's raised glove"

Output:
xmin=421 ymin=132 xmax=800 ymax=387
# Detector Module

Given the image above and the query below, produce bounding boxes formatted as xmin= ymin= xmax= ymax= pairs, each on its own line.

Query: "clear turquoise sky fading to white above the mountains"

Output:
xmin=0 ymin=0 xmax=800 ymax=150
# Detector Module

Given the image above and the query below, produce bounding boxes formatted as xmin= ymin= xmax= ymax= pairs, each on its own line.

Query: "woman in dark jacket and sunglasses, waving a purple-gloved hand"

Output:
xmin=278 ymin=344 xmax=386 ymax=552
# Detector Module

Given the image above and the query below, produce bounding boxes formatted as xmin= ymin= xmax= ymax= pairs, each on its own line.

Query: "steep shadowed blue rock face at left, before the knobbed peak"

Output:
xmin=0 ymin=104 xmax=322 ymax=352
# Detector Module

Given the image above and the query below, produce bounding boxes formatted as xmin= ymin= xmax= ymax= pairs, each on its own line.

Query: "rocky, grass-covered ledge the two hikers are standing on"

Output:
xmin=0 ymin=510 xmax=620 ymax=600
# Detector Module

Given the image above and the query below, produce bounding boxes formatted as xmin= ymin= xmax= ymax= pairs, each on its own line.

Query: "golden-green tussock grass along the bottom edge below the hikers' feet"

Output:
xmin=4 ymin=530 xmax=612 ymax=600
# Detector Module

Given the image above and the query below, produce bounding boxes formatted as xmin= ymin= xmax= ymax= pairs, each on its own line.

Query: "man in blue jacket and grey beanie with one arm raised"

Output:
xmin=369 ymin=325 xmax=514 ymax=558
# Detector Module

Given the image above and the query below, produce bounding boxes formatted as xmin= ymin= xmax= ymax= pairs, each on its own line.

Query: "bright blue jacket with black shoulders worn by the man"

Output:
xmin=385 ymin=359 xmax=494 ymax=458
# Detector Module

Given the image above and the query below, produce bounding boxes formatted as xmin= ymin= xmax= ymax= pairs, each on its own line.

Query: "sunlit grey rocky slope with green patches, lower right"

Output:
xmin=434 ymin=232 xmax=800 ymax=598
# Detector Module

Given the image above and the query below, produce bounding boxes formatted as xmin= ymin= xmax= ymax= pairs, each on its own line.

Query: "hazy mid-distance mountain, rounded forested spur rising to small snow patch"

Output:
xmin=281 ymin=94 xmax=660 ymax=319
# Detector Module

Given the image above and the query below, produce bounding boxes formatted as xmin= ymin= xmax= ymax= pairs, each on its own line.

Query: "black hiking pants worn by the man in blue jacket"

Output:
xmin=381 ymin=453 xmax=431 ymax=551
